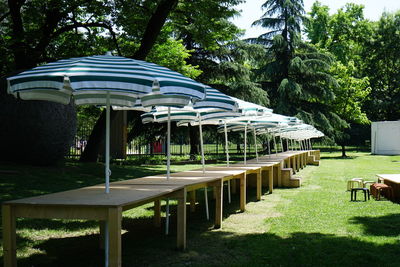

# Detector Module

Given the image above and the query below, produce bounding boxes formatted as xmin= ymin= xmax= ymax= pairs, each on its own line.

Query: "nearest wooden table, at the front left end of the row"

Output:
xmin=2 ymin=183 xmax=186 ymax=266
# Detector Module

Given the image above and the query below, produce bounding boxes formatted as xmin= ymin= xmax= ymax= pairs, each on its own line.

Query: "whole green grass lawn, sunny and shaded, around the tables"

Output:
xmin=0 ymin=152 xmax=400 ymax=266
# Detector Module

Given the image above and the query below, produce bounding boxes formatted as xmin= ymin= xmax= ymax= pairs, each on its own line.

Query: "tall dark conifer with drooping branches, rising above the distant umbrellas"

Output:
xmin=249 ymin=0 xmax=340 ymax=138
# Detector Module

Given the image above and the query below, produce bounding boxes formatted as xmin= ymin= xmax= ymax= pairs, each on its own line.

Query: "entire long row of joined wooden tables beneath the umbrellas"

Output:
xmin=2 ymin=151 xmax=316 ymax=266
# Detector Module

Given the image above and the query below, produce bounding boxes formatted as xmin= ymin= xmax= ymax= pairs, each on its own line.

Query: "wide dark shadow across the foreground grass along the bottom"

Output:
xmin=7 ymin=224 xmax=400 ymax=266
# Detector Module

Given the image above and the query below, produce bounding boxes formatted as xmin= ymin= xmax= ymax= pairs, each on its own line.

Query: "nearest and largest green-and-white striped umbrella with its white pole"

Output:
xmin=7 ymin=55 xmax=205 ymax=266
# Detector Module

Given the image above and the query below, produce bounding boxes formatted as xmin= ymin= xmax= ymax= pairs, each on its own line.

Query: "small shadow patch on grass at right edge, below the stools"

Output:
xmin=350 ymin=214 xmax=400 ymax=236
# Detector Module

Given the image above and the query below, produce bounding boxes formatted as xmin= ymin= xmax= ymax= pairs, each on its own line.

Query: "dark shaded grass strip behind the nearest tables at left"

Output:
xmin=0 ymin=162 xmax=164 ymax=202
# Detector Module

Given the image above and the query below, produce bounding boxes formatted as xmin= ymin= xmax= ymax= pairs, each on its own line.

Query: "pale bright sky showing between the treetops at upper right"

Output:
xmin=233 ymin=0 xmax=400 ymax=38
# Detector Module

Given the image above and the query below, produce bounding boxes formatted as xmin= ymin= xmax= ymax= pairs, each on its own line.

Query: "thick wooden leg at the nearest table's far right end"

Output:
xmin=176 ymin=188 xmax=186 ymax=250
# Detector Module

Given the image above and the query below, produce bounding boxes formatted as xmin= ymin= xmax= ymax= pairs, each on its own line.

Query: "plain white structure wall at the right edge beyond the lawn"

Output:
xmin=371 ymin=120 xmax=400 ymax=155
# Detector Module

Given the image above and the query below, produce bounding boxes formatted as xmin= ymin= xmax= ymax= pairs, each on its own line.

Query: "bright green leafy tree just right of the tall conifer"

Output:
xmin=305 ymin=2 xmax=374 ymax=153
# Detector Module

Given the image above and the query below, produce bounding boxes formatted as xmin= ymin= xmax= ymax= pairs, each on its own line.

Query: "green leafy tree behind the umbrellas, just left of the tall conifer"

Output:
xmin=166 ymin=0 xmax=247 ymax=154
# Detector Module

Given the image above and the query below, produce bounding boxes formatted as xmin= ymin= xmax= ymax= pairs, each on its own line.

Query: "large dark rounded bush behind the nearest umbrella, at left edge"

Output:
xmin=0 ymin=79 xmax=76 ymax=165
